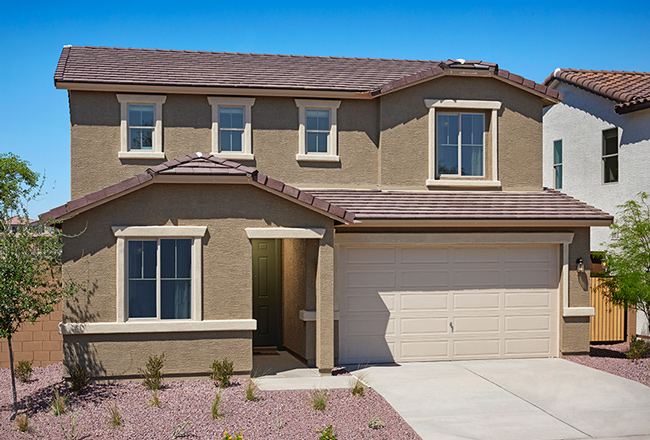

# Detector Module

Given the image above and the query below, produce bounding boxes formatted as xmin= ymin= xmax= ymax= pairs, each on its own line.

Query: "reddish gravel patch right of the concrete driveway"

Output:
xmin=566 ymin=342 xmax=650 ymax=387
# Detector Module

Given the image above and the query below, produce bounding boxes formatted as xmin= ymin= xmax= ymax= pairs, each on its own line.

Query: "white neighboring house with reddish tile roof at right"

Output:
xmin=544 ymin=69 xmax=650 ymax=334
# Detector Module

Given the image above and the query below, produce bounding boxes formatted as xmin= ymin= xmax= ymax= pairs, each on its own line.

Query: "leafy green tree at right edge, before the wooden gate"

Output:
xmin=605 ymin=192 xmax=650 ymax=334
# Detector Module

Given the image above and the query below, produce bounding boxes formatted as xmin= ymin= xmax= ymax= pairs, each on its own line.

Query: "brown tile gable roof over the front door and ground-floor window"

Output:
xmin=40 ymin=153 xmax=354 ymax=222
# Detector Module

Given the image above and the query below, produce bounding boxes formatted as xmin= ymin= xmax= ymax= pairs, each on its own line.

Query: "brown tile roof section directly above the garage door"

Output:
xmin=302 ymin=189 xmax=613 ymax=223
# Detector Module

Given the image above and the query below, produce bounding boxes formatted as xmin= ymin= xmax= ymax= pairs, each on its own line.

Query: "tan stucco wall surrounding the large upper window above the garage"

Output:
xmin=380 ymin=77 xmax=542 ymax=190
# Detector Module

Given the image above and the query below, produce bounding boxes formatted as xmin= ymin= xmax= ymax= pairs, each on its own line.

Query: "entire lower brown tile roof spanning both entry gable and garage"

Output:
xmin=41 ymin=153 xmax=612 ymax=222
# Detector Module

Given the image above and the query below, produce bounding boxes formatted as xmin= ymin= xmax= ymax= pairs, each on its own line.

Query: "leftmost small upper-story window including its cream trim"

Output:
xmin=117 ymin=94 xmax=166 ymax=159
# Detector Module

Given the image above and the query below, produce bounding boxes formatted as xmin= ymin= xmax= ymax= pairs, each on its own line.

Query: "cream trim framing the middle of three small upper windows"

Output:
xmin=208 ymin=96 xmax=255 ymax=160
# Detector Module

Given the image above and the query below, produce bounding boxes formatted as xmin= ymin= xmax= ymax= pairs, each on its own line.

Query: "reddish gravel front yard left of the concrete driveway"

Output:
xmin=0 ymin=364 xmax=420 ymax=440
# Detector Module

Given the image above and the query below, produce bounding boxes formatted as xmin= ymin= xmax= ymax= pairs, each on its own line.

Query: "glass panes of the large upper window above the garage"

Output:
xmin=436 ymin=113 xmax=485 ymax=177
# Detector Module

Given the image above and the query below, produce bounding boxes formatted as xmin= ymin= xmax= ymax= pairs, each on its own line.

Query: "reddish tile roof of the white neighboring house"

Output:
xmin=544 ymin=69 xmax=650 ymax=113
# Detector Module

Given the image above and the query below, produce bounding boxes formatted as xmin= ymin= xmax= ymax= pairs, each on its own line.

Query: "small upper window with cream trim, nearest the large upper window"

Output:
xmin=296 ymin=99 xmax=341 ymax=162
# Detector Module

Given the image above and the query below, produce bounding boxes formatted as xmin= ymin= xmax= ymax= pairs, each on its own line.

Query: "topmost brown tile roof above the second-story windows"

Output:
xmin=54 ymin=46 xmax=561 ymax=101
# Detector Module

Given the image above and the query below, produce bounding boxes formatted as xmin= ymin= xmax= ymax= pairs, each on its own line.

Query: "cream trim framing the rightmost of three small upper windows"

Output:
xmin=295 ymin=99 xmax=341 ymax=162
